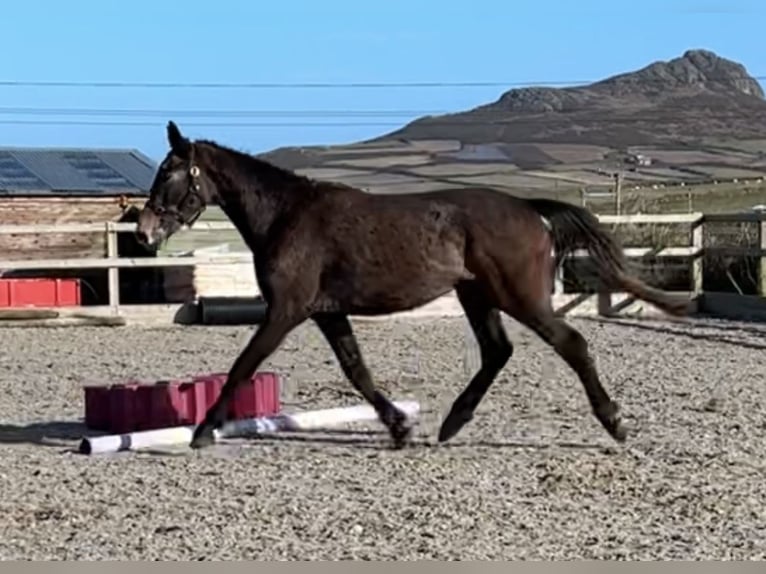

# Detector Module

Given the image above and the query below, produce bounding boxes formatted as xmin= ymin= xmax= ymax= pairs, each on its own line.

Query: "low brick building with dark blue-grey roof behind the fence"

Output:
xmin=0 ymin=147 xmax=162 ymax=306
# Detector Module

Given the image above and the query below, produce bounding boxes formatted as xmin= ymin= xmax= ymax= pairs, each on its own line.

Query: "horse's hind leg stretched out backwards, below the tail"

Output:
xmin=516 ymin=305 xmax=627 ymax=442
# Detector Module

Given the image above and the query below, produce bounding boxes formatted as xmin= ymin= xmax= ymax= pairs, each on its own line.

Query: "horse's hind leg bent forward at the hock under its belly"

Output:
xmin=439 ymin=282 xmax=513 ymax=442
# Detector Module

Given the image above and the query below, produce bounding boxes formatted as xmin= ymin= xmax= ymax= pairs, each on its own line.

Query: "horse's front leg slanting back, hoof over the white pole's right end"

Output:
xmin=313 ymin=313 xmax=412 ymax=448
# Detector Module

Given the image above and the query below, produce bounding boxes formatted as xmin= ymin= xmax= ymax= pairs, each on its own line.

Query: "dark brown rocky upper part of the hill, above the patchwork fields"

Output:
xmin=376 ymin=50 xmax=766 ymax=147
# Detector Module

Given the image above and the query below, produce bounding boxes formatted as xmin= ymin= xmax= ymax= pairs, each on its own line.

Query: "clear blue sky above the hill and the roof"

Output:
xmin=0 ymin=0 xmax=766 ymax=159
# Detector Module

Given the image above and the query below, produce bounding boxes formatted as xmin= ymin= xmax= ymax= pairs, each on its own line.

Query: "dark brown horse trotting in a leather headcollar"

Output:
xmin=137 ymin=122 xmax=688 ymax=448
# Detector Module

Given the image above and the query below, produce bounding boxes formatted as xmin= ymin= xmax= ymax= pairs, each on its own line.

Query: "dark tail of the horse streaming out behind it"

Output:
xmin=527 ymin=199 xmax=690 ymax=316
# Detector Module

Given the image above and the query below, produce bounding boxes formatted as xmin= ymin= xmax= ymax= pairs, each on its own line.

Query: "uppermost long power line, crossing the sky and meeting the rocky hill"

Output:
xmin=0 ymin=74 xmax=766 ymax=89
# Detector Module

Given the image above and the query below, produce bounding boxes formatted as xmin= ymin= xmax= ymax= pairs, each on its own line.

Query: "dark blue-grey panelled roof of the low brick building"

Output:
xmin=0 ymin=147 xmax=157 ymax=196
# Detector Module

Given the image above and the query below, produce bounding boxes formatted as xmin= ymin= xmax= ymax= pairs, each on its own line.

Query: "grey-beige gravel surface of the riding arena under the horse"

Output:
xmin=0 ymin=318 xmax=766 ymax=560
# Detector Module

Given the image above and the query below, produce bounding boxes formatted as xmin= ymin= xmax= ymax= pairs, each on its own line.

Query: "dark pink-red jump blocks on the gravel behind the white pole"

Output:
xmin=85 ymin=372 xmax=281 ymax=434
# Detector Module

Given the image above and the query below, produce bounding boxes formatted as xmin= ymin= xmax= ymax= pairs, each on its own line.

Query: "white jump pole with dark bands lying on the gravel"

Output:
xmin=79 ymin=401 xmax=420 ymax=454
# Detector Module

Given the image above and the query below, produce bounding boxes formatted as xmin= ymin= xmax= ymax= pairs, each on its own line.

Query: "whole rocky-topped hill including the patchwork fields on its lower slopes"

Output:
xmin=262 ymin=50 xmax=766 ymax=208
